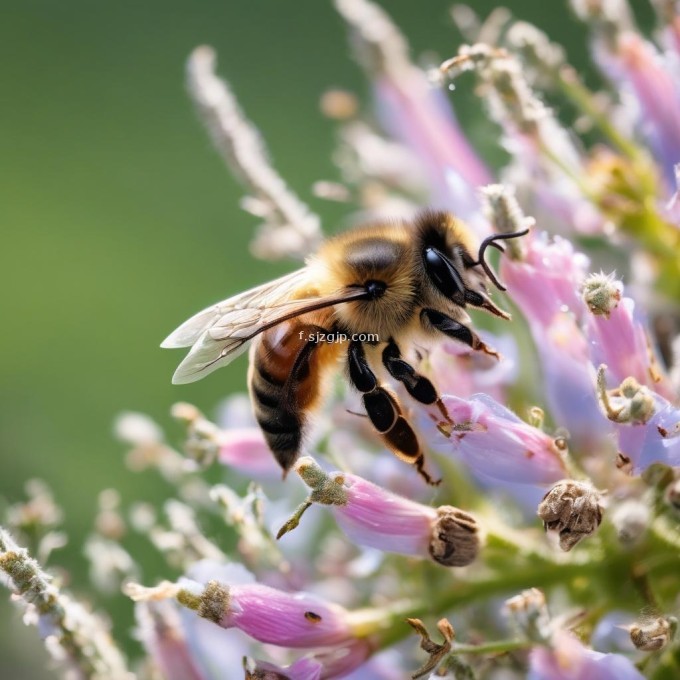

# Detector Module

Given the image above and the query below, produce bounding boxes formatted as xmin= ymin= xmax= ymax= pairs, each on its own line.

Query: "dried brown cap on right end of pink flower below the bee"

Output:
xmin=430 ymin=505 xmax=479 ymax=567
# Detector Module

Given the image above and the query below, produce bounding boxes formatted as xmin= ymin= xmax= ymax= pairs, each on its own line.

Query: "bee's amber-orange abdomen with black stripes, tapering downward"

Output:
xmin=249 ymin=319 xmax=341 ymax=472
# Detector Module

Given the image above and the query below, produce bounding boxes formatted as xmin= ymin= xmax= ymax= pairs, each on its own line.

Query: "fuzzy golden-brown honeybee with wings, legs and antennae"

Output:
xmin=161 ymin=211 xmax=528 ymax=484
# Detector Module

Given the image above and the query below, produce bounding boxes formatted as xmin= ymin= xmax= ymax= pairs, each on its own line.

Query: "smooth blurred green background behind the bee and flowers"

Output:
xmin=0 ymin=0 xmax=632 ymax=678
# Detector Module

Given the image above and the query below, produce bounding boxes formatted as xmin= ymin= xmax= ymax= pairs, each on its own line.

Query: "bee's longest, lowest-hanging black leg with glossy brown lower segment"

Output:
xmin=347 ymin=340 xmax=441 ymax=485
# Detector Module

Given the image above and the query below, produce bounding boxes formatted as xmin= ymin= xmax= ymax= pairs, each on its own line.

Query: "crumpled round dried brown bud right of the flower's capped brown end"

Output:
xmin=538 ymin=479 xmax=603 ymax=552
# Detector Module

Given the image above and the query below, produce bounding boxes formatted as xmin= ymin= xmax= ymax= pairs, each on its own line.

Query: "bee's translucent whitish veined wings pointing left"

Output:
xmin=161 ymin=269 xmax=366 ymax=384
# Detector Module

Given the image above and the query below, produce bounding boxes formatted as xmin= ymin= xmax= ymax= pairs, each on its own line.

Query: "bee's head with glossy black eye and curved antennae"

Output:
xmin=416 ymin=212 xmax=520 ymax=319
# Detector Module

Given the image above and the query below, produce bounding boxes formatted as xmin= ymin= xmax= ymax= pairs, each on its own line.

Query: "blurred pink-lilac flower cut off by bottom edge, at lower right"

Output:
xmin=528 ymin=631 xmax=644 ymax=680
